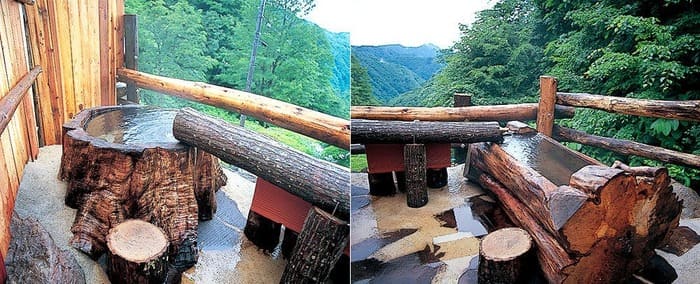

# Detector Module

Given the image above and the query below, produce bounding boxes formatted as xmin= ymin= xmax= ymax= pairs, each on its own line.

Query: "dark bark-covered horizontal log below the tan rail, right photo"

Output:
xmin=351 ymin=119 xmax=503 ymax=144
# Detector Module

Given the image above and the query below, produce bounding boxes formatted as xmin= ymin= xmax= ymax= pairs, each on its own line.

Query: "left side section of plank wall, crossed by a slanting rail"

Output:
xmin=0 ymin=1 xmax=41 ymax=258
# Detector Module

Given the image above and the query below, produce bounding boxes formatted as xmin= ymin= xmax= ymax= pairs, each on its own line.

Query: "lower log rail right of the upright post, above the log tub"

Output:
xmin=553 ymin=125 xmax=700 ymax=169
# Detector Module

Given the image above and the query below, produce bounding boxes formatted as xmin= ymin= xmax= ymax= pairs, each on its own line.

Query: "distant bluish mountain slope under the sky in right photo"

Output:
xmin=352 ymin=44 xmax=442 ymax=103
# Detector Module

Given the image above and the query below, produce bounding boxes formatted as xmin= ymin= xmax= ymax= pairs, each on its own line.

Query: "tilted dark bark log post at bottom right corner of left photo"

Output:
xmin=280 ymin=207 xmax=350 ymax=283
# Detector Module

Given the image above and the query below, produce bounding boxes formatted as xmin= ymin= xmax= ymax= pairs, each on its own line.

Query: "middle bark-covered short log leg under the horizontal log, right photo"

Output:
xmin=403 ymin=144 xmax=428 ymax=208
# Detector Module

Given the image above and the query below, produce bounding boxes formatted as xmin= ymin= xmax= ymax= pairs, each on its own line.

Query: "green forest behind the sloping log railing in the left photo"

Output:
xmin=125 ymin=0 xmax=350 ymax=167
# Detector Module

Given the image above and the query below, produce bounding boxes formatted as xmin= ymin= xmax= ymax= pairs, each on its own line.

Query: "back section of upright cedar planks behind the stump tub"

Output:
xmin=26 ymin=0 xmax=124 ymax=145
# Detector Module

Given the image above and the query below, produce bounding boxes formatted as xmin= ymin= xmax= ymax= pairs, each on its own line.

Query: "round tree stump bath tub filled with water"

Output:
xmin=59 ymin=106 xmax=226 ymax=269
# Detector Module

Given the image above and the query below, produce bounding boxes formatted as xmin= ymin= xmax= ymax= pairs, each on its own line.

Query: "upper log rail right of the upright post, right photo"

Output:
xmin=557 ymin=93 xmax=700 ymax=121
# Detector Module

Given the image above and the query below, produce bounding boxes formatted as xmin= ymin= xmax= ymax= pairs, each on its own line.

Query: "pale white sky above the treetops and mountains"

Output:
xmin=305 ymin=0 xmax=496 ymax=48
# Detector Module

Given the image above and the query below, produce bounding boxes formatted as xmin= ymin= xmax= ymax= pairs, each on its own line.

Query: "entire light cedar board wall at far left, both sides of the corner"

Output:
xmin=0 ymin=0 xmax=124 ymax=257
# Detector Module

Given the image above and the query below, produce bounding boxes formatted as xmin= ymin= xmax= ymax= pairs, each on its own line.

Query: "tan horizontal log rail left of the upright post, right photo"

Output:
xmin=350 ymin=103 xmax=575 ymax=121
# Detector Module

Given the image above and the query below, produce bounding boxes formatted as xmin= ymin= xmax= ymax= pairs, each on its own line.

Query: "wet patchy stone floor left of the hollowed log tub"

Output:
xmin=350 ymin=166 xmax=493 ymax=283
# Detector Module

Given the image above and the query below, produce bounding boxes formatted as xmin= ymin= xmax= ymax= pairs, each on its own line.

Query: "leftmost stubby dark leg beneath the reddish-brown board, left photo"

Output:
xmin=243 ymin=210 xmax=282 ymax=252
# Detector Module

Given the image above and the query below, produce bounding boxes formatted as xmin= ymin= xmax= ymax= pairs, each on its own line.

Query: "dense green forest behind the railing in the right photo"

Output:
xmin=353 ymin=0 xmax=700 ymax=188
